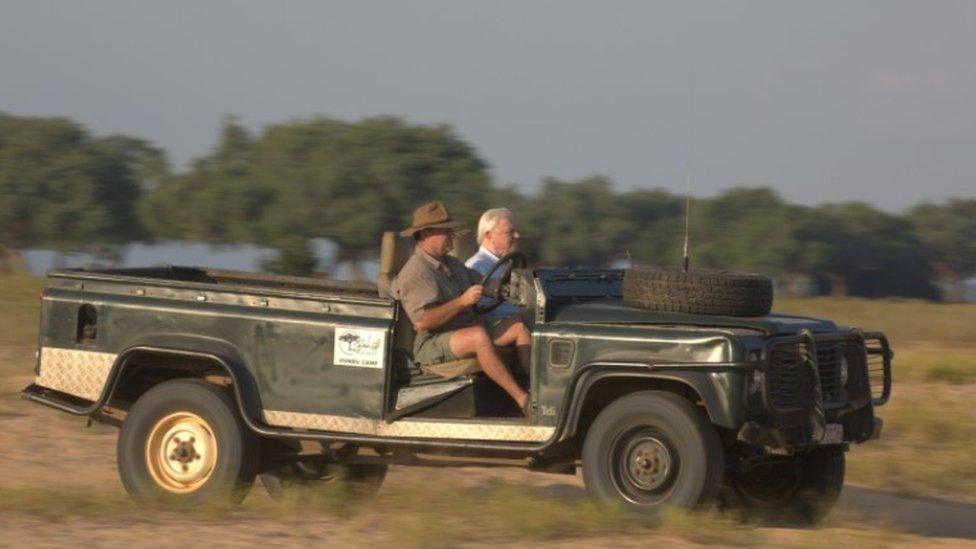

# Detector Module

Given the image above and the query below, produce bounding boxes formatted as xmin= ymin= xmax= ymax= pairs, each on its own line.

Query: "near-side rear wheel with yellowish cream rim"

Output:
xmin=117 ymin=379 xmax=259 ymax=504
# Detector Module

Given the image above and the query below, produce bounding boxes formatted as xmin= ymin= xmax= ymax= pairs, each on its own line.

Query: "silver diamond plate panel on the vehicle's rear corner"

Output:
xmin=35 ymin=347 xmax=118 ymax=401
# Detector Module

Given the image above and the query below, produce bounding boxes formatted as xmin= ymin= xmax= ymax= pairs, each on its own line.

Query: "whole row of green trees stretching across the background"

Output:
xmin=0 ymin=113 xmax=976 ymax=300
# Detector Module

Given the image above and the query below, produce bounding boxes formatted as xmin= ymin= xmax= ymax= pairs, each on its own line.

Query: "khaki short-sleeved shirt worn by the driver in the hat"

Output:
xmin=392 ymin=246 xmax=480 ymax=340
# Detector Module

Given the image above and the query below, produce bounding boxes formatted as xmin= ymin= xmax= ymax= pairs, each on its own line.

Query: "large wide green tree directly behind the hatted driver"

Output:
xmin=141 ymin=117 xmax=491 ymax=273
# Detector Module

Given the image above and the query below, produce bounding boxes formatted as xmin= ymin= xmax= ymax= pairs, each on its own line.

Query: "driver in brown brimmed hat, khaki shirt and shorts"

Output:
xmin=392 ymin=202 xmax=532 ymax=412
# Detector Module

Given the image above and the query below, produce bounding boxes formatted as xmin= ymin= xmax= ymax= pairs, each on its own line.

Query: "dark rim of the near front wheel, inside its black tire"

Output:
xmin=610 ymin=428 xmax=680 ymax=505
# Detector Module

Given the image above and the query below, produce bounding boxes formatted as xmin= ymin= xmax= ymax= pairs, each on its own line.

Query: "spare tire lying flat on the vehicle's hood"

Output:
xmin=624 ymin=266 xmax=773 ymax=316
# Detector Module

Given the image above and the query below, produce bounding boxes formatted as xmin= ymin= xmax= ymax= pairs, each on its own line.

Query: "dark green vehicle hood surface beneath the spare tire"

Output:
xmin=550 ymin=299 xmax=838 ymax=335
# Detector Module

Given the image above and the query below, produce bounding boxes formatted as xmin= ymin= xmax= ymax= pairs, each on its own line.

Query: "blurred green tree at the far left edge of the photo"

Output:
xmin=0 ymin=113 xmax=166 ymax=268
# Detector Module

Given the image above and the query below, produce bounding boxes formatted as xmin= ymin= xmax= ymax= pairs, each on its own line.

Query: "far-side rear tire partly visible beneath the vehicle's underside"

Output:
xmin=260 ymin=463 xmax=388 ymax=502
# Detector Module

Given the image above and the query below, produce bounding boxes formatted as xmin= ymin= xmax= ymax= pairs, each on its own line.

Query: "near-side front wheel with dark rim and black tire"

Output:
xmin=582 ymin=391 xmax=724 ymax=511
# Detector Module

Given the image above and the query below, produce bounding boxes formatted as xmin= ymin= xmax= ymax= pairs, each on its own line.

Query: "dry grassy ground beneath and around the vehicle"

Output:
xmin=0 ymin=278 xmax=976 ymax=547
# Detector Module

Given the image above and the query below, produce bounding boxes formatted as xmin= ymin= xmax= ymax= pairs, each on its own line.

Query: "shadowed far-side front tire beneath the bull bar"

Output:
xmin=723 ymin=446 xmax=845 ymax=525
